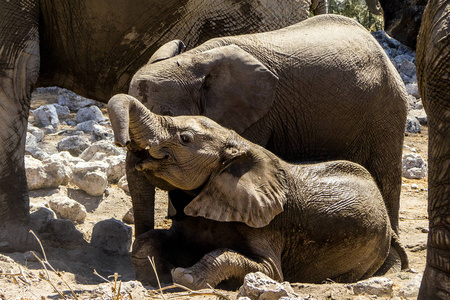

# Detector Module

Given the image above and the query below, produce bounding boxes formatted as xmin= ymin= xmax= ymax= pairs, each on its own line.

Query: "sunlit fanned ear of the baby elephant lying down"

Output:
xmin=184 ymin=149 xmax=286 ymax=228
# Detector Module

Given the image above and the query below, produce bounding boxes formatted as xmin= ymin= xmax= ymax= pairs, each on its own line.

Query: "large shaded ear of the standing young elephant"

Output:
xmin=194 ymin=45 xmax=278 ymax=133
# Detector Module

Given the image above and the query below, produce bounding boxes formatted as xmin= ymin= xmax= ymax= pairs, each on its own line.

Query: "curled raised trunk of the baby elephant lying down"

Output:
xmin=108 ymin=94 xmax=167 ymax=149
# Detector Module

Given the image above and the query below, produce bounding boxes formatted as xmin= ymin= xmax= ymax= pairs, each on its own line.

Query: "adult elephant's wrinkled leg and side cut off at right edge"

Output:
xmin=416 ymin=0 xmax=450 ymax=299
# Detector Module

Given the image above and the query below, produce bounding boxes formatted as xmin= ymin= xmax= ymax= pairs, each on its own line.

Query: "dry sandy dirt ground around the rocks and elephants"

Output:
xmin=0 ymin=94 xmax=428 ymax=299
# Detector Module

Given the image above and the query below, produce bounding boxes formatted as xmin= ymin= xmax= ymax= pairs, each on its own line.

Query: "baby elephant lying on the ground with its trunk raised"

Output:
xmin=108 ymin=95 xmax=407 ymax=289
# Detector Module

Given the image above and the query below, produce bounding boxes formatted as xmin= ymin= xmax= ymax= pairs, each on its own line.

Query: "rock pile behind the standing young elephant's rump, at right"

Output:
xmin=372 ymin=30 xmax=427 ymax=133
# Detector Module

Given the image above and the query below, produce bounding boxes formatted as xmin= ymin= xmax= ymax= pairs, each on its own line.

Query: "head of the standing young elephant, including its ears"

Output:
xmin=129 ymin=41 xmax=278 ymax=133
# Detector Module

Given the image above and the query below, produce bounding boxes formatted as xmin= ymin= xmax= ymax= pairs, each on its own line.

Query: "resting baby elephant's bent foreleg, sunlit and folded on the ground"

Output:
xmin=172 ymin=249 xmax=283 ymax=289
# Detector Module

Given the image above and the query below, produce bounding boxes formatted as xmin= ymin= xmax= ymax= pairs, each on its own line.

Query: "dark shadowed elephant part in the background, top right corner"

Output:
xmin=366 ymin=0 xmax=428 ymax=49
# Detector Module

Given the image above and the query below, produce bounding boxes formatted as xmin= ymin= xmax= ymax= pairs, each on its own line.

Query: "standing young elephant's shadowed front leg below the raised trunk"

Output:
xmin=126 ymin=151 xmax=155 ymax=236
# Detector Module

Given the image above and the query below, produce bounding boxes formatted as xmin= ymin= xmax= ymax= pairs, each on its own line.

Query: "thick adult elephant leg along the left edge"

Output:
xmin=0 ymin=1 xmax=40 ymax=251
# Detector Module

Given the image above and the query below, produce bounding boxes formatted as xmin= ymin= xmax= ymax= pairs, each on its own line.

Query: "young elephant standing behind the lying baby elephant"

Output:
xmin=127 ymin=15 xmax=407 ymax=251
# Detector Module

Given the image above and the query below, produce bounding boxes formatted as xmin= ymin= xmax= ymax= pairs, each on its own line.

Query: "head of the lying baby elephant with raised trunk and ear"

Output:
xmin=108 ymin=94 xmax=286 ymax=228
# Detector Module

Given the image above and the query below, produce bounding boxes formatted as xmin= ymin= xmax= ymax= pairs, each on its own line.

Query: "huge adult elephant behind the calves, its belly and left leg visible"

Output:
xmin=0 ymin=0 xmax=326 ymax=251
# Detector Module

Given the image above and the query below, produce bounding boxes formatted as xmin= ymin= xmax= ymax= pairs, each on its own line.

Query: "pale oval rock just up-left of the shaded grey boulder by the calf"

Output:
xmin=48 ymin=197 xmax=86 ymax=223
